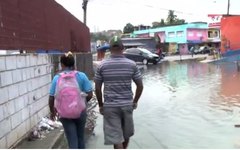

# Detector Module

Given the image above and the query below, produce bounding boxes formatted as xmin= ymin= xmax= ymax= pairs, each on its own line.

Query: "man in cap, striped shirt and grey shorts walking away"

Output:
xmin=95 ymin=36 xmax=143 ymax=149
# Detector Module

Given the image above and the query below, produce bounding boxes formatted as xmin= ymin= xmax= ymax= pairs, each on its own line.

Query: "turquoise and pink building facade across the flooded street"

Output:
xmin=133 ymin=22 xmax=208 ymax=54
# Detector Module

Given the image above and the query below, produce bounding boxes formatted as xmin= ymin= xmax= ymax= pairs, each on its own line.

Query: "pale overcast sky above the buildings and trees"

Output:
xmin=55 ymin=0 xmax=240 ymax=32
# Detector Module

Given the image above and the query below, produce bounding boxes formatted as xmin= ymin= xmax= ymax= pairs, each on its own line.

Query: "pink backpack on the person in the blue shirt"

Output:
xmin=54 ymin=71 xmax=86 ymax=119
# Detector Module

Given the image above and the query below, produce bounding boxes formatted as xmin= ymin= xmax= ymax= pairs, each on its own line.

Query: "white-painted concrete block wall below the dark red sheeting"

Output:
xmin=0 ymin=54 xmax=52 ymax=148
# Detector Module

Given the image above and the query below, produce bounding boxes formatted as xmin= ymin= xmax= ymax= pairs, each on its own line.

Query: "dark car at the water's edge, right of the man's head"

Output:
xmin=123 ymin=48 xmax=160 ymax=65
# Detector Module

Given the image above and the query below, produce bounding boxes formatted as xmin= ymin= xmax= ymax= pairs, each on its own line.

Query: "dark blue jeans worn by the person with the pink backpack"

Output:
xmin=60 ymin=111 xmax=87 ymax=149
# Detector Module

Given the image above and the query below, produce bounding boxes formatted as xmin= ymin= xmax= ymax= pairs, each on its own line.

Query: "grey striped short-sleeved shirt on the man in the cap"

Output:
xmin=95 ymin=55 xmax=142 ymax=107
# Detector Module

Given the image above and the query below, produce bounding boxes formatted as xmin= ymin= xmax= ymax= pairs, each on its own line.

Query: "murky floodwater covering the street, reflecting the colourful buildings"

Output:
xmin=88 ymin=60 xmax=240 ymax=149
